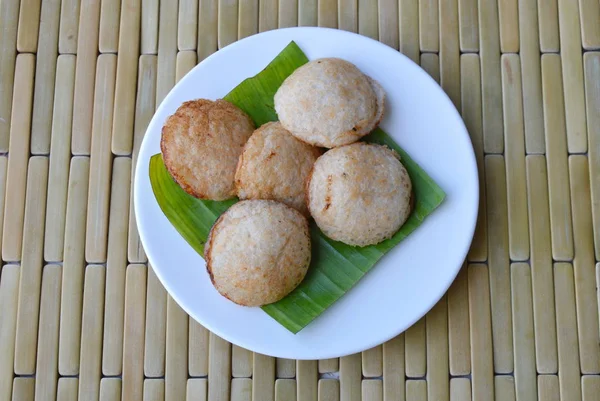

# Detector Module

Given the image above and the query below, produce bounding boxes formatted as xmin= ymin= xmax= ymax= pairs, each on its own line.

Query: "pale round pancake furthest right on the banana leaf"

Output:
xmin=307 ymin=142 xmax=412 ymax=246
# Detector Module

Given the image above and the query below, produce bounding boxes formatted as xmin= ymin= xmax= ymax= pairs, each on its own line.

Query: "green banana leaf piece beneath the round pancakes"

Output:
xmin=150 ymin=42 xmax=445 ymax=334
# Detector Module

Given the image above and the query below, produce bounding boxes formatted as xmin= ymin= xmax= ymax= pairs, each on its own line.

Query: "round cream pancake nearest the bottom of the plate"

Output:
xmin=204 ymin=200 xmax=311 ymax=306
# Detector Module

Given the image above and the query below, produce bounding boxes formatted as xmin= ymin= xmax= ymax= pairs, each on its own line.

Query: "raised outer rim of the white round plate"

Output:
xmin=132 ymin=27 xmax=480 ymax=360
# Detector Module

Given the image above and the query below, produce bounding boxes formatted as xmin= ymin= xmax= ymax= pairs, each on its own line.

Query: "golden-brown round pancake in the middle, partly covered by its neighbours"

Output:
xmin=235 ymin=122 xmax=321 ymax=215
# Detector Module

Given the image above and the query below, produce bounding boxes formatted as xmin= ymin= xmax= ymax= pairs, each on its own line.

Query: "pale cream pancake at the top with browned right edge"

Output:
xmin=274 ymin=57 xmax=385 ymax=148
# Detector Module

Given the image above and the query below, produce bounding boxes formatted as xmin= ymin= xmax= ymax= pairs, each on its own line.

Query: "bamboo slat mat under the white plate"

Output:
xmin=0 ymin=0 xmax=600 ymax=401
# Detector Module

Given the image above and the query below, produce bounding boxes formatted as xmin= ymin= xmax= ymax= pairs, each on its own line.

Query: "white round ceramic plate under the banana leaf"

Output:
xmin=134 ymin=28 xmax=479 ymax=359
